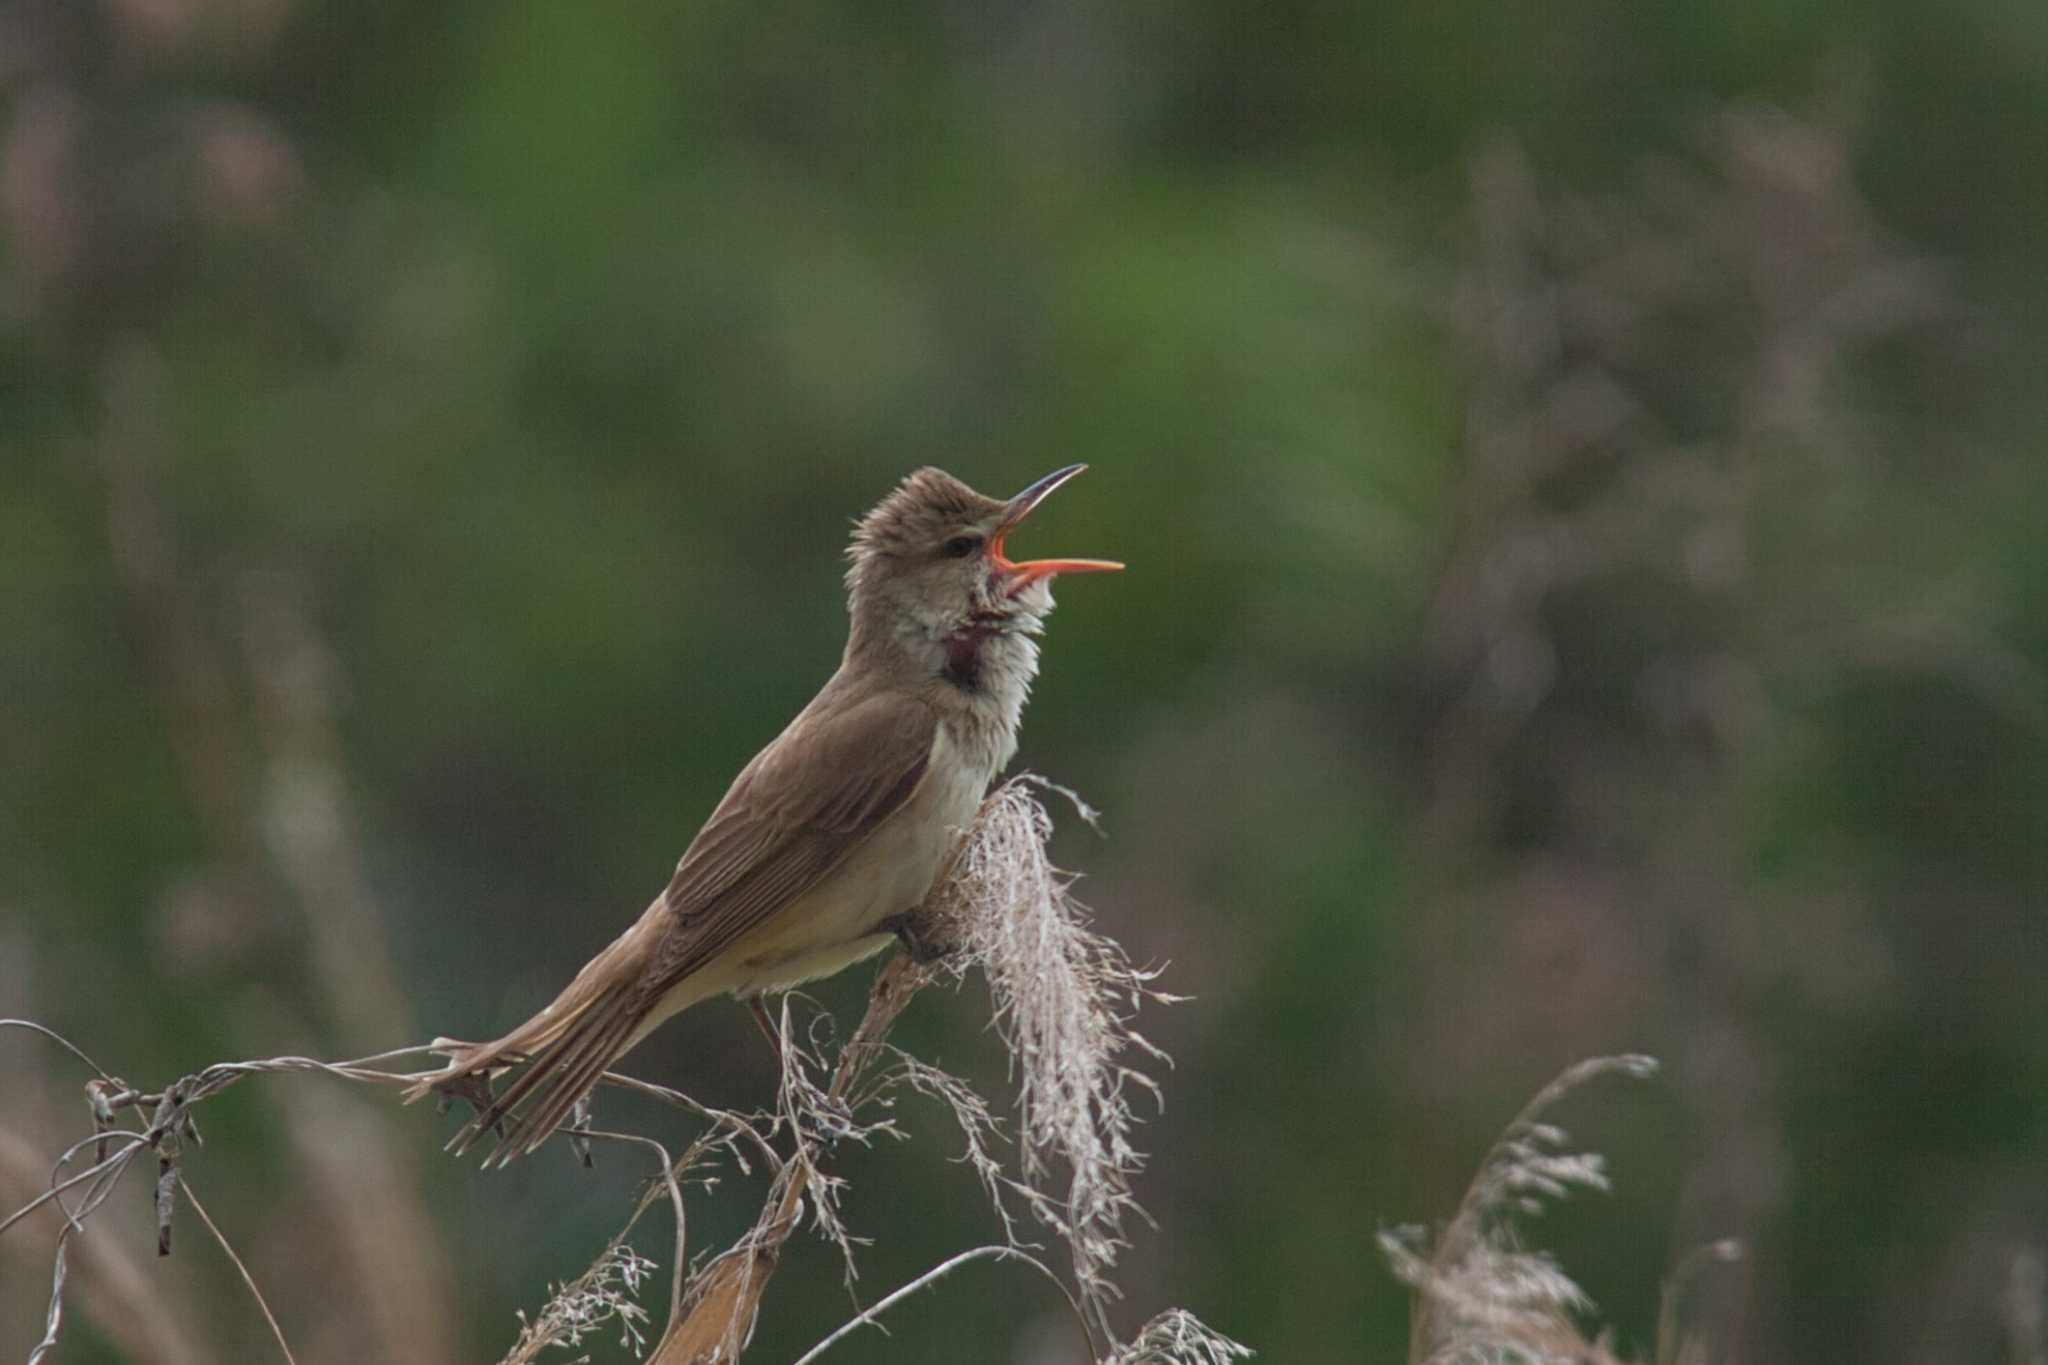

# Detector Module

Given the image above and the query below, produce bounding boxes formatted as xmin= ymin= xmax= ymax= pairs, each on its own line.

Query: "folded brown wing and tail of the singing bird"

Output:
xmin=434 ymin=679 xmax=938 ymax=1160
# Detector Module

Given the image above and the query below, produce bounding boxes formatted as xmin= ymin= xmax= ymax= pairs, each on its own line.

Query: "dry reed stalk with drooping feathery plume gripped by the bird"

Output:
xmin=651 ymin=778 xmax=1249 ymax=1365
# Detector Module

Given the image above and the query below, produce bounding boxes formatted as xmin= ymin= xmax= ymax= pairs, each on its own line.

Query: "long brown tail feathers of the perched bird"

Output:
xmin=406 ymin=921 xmax=653 ymax=1166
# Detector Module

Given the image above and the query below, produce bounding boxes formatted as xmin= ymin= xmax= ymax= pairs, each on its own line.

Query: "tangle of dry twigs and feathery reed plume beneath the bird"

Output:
xmin=0 ymin=778 xmax=1251 ymax=1365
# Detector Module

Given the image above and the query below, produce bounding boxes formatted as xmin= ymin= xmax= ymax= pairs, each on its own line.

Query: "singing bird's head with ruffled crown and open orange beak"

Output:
xmin=846 ymin=465 xmax=1122 ymax=673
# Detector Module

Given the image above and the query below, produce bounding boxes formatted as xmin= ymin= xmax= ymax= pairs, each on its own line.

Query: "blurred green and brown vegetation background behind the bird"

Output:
xmin=0 ymin=0 xmax=2048 ymax=1365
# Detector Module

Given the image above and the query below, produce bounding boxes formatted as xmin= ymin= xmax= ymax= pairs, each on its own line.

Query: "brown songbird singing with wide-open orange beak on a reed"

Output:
xmin=408 ymin=465 xmax=1122 ymax=1160
